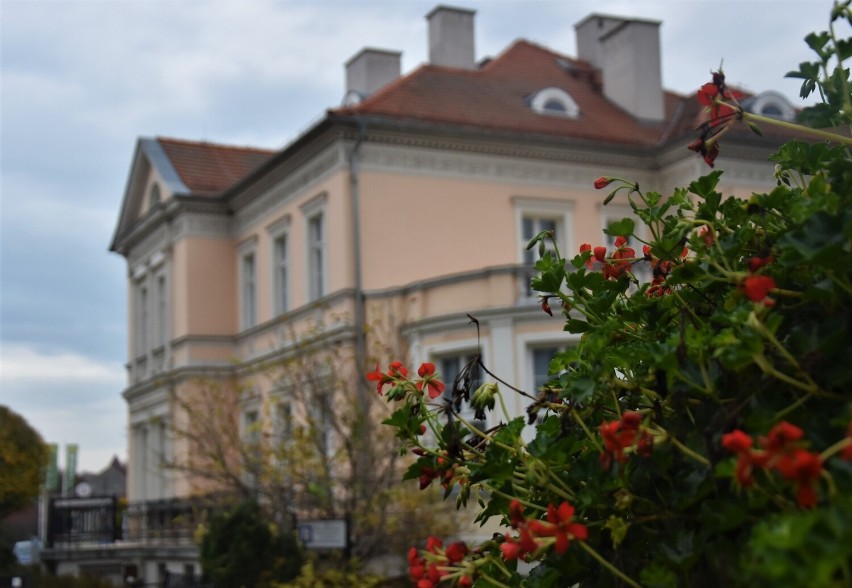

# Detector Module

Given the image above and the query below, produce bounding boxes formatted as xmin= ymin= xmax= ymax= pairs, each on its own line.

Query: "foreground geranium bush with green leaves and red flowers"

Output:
xmin=382 ymin=2 xmax=852 ymax=588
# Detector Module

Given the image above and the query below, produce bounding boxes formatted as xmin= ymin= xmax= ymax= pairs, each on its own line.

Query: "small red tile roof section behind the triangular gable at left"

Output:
xmin=157 ymin=137 xmax=276 ymax=195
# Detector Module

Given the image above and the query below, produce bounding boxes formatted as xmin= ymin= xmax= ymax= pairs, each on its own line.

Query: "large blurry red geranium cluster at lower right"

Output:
xmin=722 ymin=421 xmax=823 ymax=507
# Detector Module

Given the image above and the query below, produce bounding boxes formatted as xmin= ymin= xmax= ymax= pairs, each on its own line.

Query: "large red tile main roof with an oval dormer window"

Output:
xmin=332 ymin=40 xmax=692 ymax=146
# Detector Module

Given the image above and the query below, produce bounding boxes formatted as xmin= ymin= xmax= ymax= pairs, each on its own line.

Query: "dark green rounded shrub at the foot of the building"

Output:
xmin=200 ymin=502 xmax=303 ymax=588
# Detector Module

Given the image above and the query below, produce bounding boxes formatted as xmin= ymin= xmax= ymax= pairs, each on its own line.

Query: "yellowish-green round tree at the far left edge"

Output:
xmin=0 ymin=405 xmax=49 ymax=518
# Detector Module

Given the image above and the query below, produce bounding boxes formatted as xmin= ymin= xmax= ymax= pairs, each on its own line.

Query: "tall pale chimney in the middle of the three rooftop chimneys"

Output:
xmin=426 ymin=6 xmax=476 ymax=69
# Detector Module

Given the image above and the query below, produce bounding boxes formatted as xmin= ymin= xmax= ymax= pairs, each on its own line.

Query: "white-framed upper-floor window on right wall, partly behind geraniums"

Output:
xmin=512 ymin=196 xmax=573 ymax=296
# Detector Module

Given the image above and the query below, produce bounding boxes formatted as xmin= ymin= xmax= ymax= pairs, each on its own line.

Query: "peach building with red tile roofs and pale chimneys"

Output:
xmin=110 ymin=6 xmax=793 ymax=581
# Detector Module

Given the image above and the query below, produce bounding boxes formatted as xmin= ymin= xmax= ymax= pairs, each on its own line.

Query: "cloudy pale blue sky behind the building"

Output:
xmin=0 ymin=0 xmax=848 ymax=472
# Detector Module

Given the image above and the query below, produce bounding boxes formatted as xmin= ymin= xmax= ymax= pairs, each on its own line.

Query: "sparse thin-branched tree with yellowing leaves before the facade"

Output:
xmin=163 ymin=320 xmax=457 ymax=560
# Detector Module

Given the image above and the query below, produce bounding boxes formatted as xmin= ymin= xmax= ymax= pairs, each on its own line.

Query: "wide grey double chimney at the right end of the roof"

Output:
xmin=574 ymin=14 xmax=665 ymax=121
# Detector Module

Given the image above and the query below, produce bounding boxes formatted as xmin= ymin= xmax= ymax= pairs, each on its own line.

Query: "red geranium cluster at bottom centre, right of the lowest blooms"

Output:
xmin=500 ymin=499 xmax=589 ymax=561
